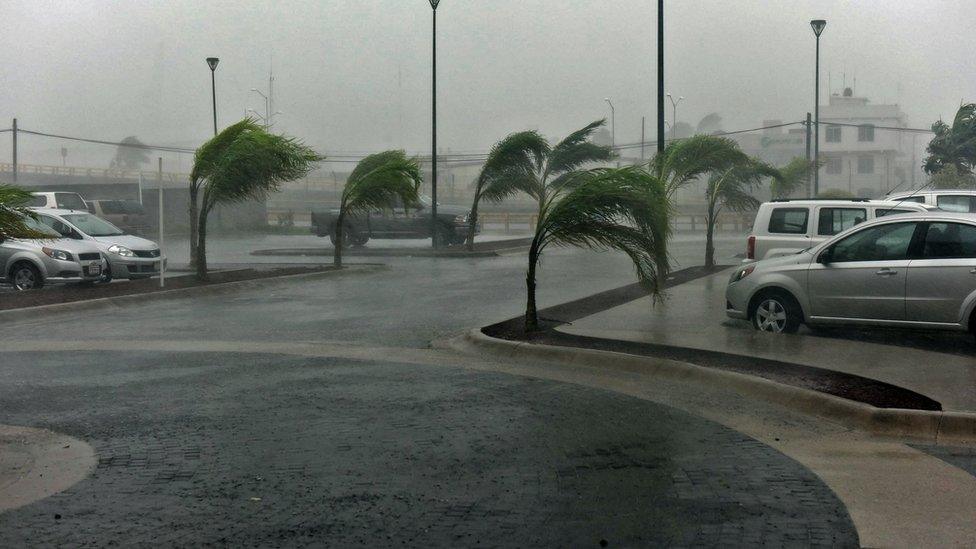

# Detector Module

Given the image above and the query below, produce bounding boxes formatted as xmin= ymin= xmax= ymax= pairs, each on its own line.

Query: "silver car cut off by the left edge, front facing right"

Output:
xmin=0 ymin=218 xmax=107 ymax=290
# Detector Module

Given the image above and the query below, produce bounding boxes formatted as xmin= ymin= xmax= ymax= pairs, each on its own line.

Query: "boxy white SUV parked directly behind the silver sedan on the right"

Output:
xmin=746 ymin=198 xmax=935 ymax=261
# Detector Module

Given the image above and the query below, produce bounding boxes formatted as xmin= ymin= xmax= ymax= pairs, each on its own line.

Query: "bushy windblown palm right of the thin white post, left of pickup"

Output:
xmin=190 ymin=118 xmax=324 ymax=280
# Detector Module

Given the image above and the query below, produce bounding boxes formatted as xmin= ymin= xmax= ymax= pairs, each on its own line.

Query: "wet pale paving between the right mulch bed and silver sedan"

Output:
xmin=557 ymin=271 xmax=976 ymax=412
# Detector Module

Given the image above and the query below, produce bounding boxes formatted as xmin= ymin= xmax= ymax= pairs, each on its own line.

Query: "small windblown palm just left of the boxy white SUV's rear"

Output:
xmin=705 ymin=158 xmax=780 ymax=268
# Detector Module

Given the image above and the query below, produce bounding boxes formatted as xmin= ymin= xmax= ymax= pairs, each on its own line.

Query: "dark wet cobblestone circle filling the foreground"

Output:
xmin=0 ymin=351 xmax=858 ymax=547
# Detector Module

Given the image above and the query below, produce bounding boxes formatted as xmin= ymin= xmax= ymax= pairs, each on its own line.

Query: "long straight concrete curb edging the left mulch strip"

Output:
xmin=0 ymin=265 xmax=389 ymax=322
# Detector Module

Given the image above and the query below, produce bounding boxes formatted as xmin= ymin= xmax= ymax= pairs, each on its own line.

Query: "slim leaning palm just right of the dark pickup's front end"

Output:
xmin=466 ymin=131 xmax=549 ymax=251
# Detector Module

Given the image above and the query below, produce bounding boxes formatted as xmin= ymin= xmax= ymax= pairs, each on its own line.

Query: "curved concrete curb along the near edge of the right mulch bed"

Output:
xmin=447 ymin=329 xmax=976 ymax=444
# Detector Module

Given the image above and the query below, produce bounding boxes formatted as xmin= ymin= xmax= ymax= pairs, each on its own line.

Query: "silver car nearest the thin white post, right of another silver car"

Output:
xmin=33 ymin=208 xmax=166 ymax=282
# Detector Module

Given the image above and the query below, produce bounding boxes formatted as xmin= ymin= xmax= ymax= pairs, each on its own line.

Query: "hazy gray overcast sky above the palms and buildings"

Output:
xmin=0 ymin=0 xmax=976 ymax=165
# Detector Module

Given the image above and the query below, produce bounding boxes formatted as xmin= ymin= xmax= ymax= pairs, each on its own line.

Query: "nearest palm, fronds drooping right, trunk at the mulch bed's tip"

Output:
xmin=525 ymin=166 xmax=671 ymax=332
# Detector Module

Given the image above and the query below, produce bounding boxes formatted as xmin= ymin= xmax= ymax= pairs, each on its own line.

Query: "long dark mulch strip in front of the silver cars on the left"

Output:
xmin=0 ymin=265 xmax=335 ymax=311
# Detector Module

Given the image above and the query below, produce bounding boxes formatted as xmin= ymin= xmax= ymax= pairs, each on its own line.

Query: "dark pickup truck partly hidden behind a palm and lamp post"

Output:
xmin=312 ymin=196 xmax=477 ymax=246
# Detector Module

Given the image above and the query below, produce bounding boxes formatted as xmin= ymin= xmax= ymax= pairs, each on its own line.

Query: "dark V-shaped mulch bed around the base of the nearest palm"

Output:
xmin=481 ymin=266 xmax=942 ymax=410
